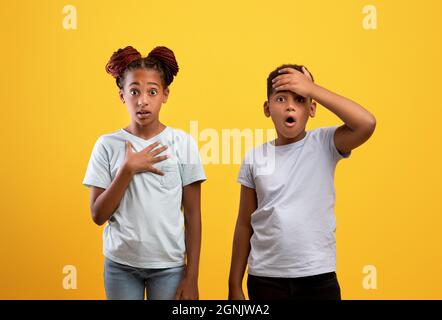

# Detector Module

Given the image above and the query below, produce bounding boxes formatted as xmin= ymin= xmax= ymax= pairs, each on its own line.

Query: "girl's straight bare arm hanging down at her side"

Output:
xmin=175 ymin=182 xmax=201 ymax=300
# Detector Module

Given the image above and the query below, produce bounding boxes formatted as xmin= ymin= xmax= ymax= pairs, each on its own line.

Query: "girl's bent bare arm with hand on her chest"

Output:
xmin=90 ymin=142 xmax=167 ymax=226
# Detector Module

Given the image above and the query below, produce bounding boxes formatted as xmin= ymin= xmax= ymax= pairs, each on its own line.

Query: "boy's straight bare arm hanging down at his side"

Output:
xmin=229 ymin=185 xmax=257 ymax=300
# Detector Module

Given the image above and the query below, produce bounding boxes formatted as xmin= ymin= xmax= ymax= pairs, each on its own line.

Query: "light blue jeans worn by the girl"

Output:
xmin=104 ymin=258 xmax=184 ymax=300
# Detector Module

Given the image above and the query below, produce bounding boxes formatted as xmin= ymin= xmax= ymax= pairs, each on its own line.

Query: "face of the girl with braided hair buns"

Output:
xmin=119 ymin=68 xmax=169 ymax=127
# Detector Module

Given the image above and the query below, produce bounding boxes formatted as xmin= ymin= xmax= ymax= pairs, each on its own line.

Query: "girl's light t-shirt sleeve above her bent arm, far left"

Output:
xmin=83 ymin=137 xmax=112 ymax=189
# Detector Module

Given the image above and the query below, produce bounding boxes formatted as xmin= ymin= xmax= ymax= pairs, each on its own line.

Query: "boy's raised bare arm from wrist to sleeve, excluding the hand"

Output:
xmin=311 ymin=84 xmax=376 ymax=153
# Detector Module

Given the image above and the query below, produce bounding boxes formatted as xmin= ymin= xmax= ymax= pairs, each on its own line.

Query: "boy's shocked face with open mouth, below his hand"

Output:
xmin=264 ymin=91 xmax=316 ymax=139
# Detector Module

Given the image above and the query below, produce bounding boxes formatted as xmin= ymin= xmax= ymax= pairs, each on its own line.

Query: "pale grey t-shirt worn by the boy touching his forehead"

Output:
xmin=238 ymin=126 xmax=350 ymax=278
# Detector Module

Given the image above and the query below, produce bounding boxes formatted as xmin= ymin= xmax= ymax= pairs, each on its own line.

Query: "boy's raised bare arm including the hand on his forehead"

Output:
xmin=273 ymin=67 xmax=376 ymax=153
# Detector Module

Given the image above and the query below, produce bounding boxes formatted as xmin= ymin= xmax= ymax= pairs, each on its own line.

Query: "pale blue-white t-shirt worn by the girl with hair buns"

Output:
xmin=83 ymin=127 xmax=206 ymax=268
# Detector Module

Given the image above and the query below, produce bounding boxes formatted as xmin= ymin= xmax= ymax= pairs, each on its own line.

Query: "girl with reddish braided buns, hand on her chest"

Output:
xmin=83 ymin=46 xmax=206 ymax=300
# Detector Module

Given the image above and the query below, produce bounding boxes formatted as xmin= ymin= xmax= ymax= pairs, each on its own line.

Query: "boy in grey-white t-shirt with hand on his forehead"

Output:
xmin=229 ymin=65 xmax=376 ymax=300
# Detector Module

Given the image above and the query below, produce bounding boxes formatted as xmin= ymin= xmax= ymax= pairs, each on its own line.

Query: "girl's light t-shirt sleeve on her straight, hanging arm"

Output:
xmin=180 ymin=135 xmax=207 ymax=187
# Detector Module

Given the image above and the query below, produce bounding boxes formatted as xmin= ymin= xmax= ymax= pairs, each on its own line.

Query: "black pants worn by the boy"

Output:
xmin=247 ymin=272 xmax=341 ymax=300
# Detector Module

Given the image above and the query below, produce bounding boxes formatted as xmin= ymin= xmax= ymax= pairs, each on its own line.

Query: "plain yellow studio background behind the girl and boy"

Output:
xmin=0 ymin=0 xmax=442 ymax=299
